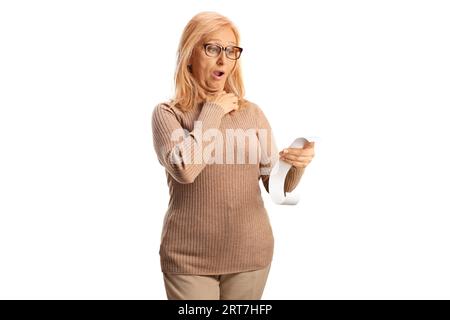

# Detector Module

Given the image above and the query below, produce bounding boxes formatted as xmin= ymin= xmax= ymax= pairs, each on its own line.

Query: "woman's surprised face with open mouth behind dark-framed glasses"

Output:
xmin=189 ymin=27 xmax=237 ymax=93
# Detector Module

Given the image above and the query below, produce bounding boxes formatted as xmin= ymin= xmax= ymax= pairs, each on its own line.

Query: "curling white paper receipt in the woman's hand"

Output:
xmin=269 ymin=137 xmax=318 ymax=205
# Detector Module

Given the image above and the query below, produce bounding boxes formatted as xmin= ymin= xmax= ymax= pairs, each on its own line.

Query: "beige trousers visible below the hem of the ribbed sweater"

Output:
xmin=163 ymin=264 xmax=270 ymax=300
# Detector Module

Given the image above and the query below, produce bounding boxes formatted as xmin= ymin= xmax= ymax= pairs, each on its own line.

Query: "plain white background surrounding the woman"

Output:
xmin=0 ymin=0 xmax=450 ymax=299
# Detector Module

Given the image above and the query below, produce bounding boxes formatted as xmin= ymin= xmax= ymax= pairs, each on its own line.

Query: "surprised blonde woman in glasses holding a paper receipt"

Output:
xmin=152 ymin=12 xmax=314 ymax=300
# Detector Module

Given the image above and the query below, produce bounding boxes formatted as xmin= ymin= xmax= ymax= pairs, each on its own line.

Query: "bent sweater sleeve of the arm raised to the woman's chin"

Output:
xmin=152 ymin=102 xmax=224 ymax=184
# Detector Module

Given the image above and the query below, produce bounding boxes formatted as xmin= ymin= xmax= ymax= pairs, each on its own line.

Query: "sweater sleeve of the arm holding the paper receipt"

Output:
xmin=256 ymin=106 xmax=305 ymax=193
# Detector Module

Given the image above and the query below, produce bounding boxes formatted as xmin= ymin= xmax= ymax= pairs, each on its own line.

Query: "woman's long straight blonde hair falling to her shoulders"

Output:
xmin=171 ymin=11 xmax=247 ymax=111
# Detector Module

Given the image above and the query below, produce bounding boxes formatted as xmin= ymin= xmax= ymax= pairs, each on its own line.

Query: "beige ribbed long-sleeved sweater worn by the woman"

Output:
xmin=152 ymin=100 xmax=304 ymax=275
